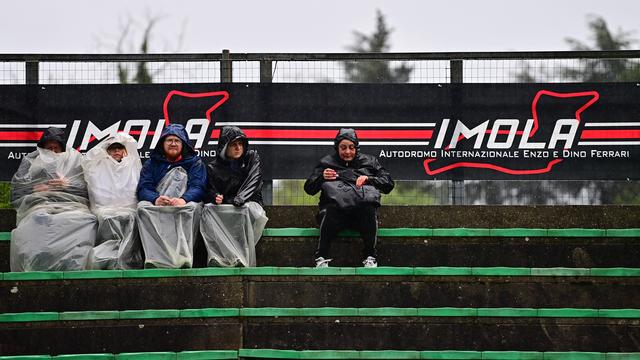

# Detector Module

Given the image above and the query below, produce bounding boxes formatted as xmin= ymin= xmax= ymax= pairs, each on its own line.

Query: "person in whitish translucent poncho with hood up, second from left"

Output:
xmin=82 ymin=133 xmax=143 ymax=269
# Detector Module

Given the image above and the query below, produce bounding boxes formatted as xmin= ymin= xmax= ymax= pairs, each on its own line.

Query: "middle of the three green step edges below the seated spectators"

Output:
xmin=0 ymin=307 xmax=640 ymax=323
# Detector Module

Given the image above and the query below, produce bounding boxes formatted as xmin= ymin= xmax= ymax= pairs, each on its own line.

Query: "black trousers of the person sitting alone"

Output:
xmin=315 ymin=204 xmax=378 ymax=259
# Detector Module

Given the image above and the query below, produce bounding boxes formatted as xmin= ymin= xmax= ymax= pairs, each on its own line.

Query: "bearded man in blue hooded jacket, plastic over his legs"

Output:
xmin=137 ymin=124 xmax=207 ymax=268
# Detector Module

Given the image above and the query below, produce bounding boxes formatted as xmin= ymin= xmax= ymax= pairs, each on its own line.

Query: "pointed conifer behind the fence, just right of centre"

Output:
xmin=344 ymin=10 xmax=413 ymax=83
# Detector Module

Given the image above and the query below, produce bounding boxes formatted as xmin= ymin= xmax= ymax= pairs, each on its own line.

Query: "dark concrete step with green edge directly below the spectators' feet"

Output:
xmin=0 ymin=267 xmax=640 ymax=312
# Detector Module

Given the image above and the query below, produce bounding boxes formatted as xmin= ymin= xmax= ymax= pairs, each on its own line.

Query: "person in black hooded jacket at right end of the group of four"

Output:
xmin=200 ymin=126 xmax=268 ymax=266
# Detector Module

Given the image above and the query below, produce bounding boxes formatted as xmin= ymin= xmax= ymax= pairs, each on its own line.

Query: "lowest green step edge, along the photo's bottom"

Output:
xmin=0 ymin=349 xmax=640 ymax=360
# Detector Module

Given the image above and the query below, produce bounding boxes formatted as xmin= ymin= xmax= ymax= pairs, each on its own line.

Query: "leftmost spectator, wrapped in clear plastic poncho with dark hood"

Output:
xmin=10 ymin=127 xmax=97 ymax=271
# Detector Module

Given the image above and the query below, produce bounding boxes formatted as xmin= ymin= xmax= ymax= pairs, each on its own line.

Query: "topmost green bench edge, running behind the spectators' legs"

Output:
xmin=0 ymin=228 xmax=640 ymax=241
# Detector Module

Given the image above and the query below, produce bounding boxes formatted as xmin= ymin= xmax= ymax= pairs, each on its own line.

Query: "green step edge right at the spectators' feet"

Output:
xmin=0 ymin=266 xmax=640 ymax=281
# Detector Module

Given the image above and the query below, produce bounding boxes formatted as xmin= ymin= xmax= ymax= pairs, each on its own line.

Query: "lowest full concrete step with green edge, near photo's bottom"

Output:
xmin=0 ymin=308 xmax=640 ymax=355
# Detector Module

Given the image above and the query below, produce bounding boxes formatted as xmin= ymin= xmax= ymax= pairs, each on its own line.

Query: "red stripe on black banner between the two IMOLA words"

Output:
xmin=211 ymin=129 xmax=433 ymax=140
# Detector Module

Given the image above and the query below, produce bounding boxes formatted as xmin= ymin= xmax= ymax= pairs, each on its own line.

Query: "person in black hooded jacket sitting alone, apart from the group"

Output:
xmin=304 ymin=128 xmax=395 ymax=267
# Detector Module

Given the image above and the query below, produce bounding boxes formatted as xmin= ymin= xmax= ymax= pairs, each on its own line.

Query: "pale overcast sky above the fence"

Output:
xmin=0 ymin=0 xmax=640 ymax=53
